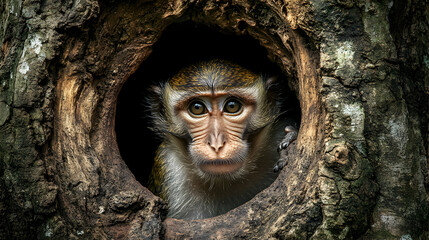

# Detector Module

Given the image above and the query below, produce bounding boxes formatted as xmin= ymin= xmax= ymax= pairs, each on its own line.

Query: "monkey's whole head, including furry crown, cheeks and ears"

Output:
xmin=153 ymin=60 xmax=279 ymax=178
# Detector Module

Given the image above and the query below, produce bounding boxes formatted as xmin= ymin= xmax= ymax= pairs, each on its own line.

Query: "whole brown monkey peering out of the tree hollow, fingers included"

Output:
xmin=145 ymin=59 xmax=298 ymax=219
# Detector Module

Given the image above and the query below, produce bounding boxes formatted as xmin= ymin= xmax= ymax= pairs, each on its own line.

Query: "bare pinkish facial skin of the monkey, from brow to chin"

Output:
xmin=175 ymin=93 xmax=256 ymax=175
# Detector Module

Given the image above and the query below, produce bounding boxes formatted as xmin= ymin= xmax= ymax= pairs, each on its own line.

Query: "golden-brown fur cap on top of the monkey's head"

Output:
xmin=169 ymin=60 xmax=260 ymax=90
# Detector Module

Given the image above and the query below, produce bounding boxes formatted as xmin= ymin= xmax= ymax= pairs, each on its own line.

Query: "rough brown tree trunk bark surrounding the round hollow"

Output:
xmin=0 ymin=0 xmax=429 ymax=239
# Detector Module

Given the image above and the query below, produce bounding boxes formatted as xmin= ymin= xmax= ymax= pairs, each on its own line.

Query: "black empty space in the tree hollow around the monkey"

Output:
xmin=115 ymin=22 xmax=301 ymax=186
